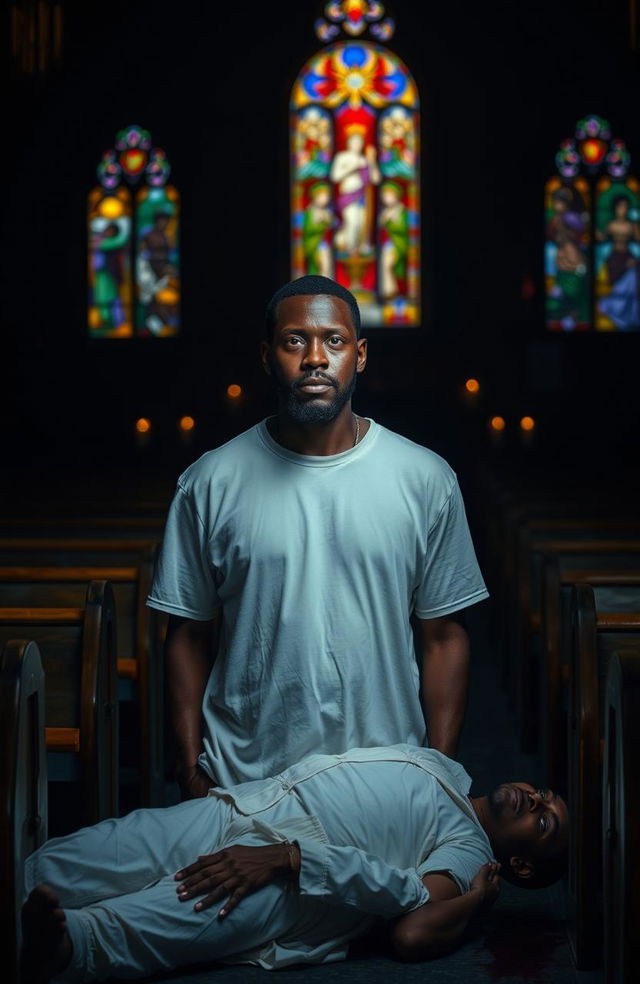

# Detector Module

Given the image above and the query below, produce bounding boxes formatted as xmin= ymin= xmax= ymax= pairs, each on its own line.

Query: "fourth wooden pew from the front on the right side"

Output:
xmin=508 ymin=527 xmax=640 ymax=753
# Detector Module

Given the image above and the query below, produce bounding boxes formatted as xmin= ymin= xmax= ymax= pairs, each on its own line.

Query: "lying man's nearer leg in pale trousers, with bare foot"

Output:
xmin=23 ymin=875 xmax=300 ymax=984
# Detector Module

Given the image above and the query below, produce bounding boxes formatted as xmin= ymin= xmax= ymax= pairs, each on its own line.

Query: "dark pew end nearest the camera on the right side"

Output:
xmin=602 ymin=646 xmax=640 ymax=984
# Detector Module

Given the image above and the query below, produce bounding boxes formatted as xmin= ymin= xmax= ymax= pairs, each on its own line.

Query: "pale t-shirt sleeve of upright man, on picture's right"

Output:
xmin=415 ymin=480 xmax=489 ymax=619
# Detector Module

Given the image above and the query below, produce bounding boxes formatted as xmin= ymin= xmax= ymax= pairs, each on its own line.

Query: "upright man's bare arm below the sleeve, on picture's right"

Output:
xmin=417 ymin=615 xmax=469 ymax=758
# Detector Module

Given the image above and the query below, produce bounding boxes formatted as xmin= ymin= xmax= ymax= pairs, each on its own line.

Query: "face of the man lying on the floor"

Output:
xmin=488 ymin=782 xmax=569 ymax=858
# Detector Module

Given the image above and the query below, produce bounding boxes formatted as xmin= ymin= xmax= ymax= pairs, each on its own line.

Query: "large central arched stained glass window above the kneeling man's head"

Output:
xmin=290 ymin=0 xmax=421 ymax=327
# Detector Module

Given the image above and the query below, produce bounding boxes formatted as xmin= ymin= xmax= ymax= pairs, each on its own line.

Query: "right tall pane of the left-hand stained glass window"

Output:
xmin=136 ymin=185 xmax=180 ymax=338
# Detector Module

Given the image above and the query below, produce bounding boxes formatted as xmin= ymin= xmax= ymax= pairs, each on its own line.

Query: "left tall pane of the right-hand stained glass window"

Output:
xmin=544 ymin=177 xmax=591 ymax=331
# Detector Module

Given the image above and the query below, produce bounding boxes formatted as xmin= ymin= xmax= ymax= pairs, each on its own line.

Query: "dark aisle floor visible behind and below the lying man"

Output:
xmin=124 ymin=601 xmax=602 ymax=984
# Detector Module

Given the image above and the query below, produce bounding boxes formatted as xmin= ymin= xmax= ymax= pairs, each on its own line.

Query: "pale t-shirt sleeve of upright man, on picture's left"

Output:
xmin=147 ymin=485 xmax=220 ymax=621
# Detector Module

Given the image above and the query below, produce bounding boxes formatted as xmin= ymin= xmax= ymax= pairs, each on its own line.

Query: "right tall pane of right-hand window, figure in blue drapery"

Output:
xmin=594 ymin=177 xmax=640 ymax=331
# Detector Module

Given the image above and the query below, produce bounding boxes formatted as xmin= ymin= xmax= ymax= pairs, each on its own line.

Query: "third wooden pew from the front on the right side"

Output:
xmin=539 ymin=553 xmax=640 ymax=791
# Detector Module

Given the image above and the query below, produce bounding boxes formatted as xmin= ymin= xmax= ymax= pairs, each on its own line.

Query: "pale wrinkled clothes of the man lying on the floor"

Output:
xmin=26 ymin=745 xmax=492 ymax=984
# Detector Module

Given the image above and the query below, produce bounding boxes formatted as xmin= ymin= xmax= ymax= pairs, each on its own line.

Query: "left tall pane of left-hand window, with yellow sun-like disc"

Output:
xmin=87 ymin=187 xmax=133 ymax=338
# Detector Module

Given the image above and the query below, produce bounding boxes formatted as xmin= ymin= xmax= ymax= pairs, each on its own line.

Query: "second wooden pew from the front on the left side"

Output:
xmin=0 ymin=581 xmax=118 ymax=835
